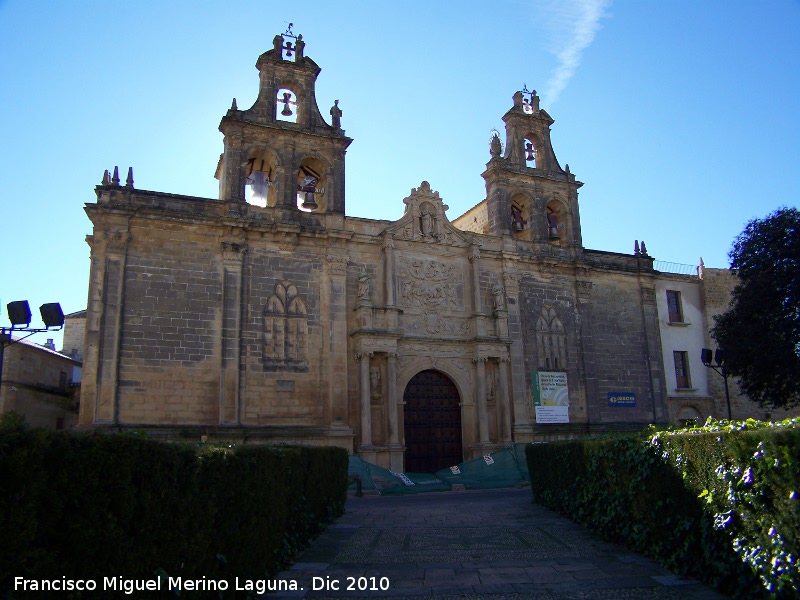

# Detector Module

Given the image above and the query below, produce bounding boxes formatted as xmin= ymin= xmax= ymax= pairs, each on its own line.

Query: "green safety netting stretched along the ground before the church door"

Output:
xmin=349 ymin=444 xmax=530 ymax=495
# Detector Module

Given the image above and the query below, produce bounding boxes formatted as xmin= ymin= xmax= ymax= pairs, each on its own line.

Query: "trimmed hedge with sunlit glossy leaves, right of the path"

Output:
xmin=526 ymin=420 xmax=800 ymax=598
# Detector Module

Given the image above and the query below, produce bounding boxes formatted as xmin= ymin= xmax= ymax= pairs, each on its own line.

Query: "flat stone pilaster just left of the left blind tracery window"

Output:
xmin=219 ymin=239 xmax=245 ymax=425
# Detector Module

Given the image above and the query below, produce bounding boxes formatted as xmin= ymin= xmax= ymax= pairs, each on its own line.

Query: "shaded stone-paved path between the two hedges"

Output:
xmin=270 ymin=488 xmax=724 ymax=600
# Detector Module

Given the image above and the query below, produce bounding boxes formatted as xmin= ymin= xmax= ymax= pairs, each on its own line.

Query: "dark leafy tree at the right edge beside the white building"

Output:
xmin=711 ymin=207 xmax=800 ymax=408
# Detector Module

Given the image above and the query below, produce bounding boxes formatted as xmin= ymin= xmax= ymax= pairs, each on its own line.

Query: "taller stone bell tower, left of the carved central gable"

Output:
xmin=216 ymin=23 xmax=352 ymax=215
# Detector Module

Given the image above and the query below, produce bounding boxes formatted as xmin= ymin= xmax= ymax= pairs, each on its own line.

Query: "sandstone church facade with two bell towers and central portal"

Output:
xmin=80 ymin=33 xmax=669 ymax=471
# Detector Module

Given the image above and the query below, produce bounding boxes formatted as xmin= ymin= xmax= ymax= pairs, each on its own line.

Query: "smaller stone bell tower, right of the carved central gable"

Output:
xmin=483 ymin=89 xmax=583 ymax=256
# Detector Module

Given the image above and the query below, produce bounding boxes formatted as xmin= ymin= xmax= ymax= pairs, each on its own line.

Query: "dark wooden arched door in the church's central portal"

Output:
xmin=403 ymin=370 xmax=464 ymax=473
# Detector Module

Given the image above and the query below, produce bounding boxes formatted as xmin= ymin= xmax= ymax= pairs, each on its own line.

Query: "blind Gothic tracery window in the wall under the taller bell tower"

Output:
xmin=264 ymin=281 xmax=308 ymax=371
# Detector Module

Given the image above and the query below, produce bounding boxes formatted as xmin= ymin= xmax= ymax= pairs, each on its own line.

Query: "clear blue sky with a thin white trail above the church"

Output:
xmin=0 ymin=0 xmax=800 ymax=347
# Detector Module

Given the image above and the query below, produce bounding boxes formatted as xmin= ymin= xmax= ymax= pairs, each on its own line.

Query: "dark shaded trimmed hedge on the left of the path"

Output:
xmin=0 ymin=418 xmax=348 ymax=595
